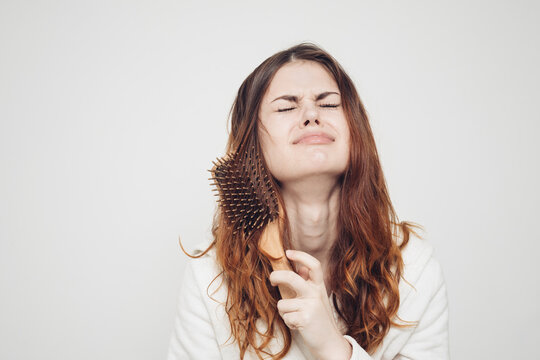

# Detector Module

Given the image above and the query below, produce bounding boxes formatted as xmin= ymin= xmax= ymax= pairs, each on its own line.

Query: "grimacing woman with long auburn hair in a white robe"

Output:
xmin=168 ymin=43 xmax=449 ymax=360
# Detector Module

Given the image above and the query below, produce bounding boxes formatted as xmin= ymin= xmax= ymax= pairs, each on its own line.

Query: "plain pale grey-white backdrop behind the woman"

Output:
xmin=0 ymin=0 xmax=540 ymax=360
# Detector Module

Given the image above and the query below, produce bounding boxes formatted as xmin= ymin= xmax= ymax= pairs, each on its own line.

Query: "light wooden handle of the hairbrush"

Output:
xmin=259 ymin=219 xmax=296 ymax=299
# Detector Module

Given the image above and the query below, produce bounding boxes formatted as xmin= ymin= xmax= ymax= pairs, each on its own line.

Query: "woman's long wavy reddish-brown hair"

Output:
xmin=184 ymin=43 xmax=421 ymax=359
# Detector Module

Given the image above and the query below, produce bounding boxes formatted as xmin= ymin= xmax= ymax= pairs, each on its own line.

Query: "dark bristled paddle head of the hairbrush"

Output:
xmin=208 ymin=147 xmax=279 ymax=237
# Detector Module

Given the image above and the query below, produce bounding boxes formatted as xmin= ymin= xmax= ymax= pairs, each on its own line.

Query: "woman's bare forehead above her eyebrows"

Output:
xmin=265 ymin=61 xmax=338 ymax=99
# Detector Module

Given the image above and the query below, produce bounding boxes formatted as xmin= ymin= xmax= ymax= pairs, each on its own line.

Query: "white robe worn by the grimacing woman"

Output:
xmin=167 ymin=233 xmax=450 ymax=360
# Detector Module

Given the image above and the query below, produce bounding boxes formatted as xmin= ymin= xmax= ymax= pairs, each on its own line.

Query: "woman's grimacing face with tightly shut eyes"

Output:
xmin=259 ymin=61 xmax=350 ymax=182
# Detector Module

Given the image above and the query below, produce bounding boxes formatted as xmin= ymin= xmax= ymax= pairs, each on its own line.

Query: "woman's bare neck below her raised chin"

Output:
xmin=281 ymin=176 xmax=341 ymax=282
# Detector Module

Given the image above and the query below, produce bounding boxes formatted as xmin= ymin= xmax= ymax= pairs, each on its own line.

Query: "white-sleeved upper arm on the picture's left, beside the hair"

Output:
xmin=167 ymin=259 xmax=221 ymax=360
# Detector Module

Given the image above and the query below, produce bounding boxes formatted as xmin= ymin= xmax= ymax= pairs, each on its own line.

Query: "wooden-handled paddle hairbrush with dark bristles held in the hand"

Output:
xmin=208 ymin=147 xmax=295 ymax=299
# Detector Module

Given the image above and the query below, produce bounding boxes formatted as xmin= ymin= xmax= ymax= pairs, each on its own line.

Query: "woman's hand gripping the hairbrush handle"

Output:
xmin=270 ymin=250 xmax=352 ymax=360
